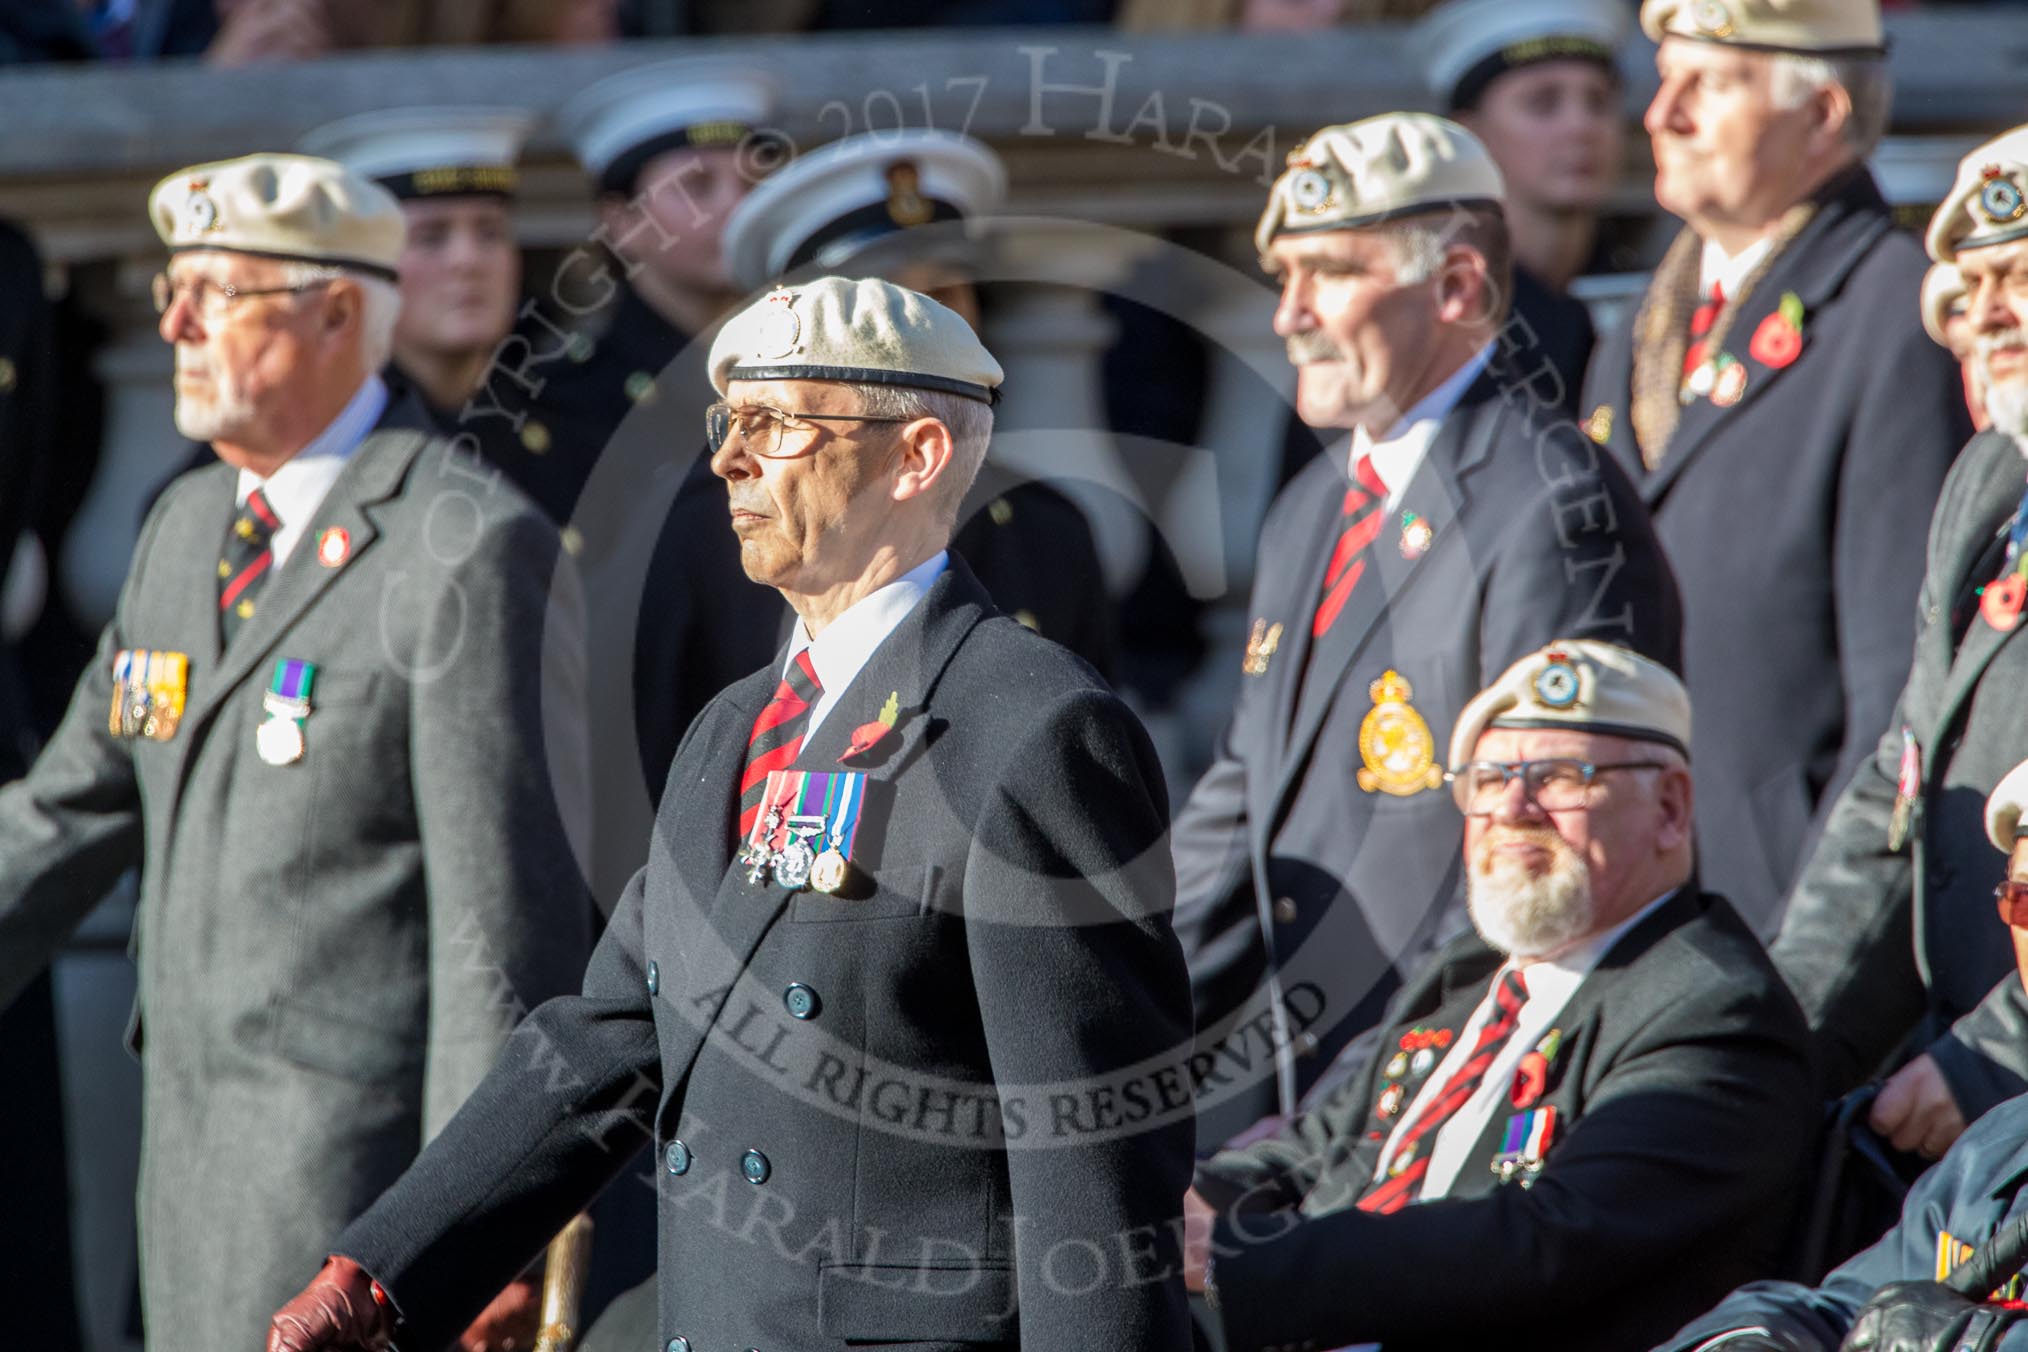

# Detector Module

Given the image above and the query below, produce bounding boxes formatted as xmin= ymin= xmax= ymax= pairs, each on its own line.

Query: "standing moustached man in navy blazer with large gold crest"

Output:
xmin=1174 ymin=114 xmax=1683 ymax=1145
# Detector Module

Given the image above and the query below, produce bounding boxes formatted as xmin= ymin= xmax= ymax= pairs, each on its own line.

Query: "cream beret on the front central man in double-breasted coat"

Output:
xmin=710 ymin=278 xmax=1002 ymax=403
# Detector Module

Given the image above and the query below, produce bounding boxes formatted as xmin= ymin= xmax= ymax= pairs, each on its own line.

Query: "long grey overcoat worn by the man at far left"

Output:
xmin=0 ymin=407 xmax=588 ymax=1348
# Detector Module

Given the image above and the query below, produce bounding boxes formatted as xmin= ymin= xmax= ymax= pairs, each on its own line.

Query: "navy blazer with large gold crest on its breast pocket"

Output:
xmin=1174 ymin=354 xmax=1681 ymax=1143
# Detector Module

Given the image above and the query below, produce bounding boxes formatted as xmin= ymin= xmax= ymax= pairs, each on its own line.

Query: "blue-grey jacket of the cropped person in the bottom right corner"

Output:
xmin=1657 ymin=1094 xmax=2028 ymax=1352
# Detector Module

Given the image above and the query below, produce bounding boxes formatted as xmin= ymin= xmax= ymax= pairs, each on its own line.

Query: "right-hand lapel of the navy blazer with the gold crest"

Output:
xmin=1261 ymin=367 xmax=1503 ymax=839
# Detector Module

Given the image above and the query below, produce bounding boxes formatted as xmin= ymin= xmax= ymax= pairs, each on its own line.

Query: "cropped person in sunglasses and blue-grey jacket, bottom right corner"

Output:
xmin=1663 ymin=762 xmax=2028 ymax=1352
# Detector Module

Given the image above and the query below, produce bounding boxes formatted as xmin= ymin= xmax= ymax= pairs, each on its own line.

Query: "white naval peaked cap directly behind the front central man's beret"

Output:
xmin=722 ymin=132 xmax=1008 ymax=290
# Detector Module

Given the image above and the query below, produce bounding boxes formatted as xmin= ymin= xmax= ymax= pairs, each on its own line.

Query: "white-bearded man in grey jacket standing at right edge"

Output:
xmin=1772 ymin=128 xmax=2028 ymax=1159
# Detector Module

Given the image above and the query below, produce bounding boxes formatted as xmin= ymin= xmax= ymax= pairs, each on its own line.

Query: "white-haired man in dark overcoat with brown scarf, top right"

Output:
xmin=1584 ymin=0 xmax=1971 ymax=932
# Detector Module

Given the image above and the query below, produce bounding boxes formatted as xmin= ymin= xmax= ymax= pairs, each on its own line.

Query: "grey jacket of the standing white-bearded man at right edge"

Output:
xmin=1772 ymin=432 xmax=2028 ymax=1119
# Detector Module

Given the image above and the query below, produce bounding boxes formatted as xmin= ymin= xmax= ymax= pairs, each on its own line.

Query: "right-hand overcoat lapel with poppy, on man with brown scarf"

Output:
xmin=1637 ymin=170 xmax=1894 ymax=507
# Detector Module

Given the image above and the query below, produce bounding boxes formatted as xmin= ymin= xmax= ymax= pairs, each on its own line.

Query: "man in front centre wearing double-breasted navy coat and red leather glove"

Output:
xmin=270 ymin=278 xmax=1192 ymax=1352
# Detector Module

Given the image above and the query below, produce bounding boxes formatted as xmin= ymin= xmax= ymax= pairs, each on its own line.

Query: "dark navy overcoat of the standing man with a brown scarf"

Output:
xmin=1584 ymin=168 xmax=1971 ymax=932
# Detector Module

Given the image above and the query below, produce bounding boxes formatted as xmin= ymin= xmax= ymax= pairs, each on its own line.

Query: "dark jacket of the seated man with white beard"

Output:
xmin=1197 ymin=884 xmax=1817 ymax=1352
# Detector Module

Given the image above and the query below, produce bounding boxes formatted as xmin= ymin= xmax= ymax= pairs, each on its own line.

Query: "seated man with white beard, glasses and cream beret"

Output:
xmin=1184 ymin=639 xmax=1817 ymax=1352
